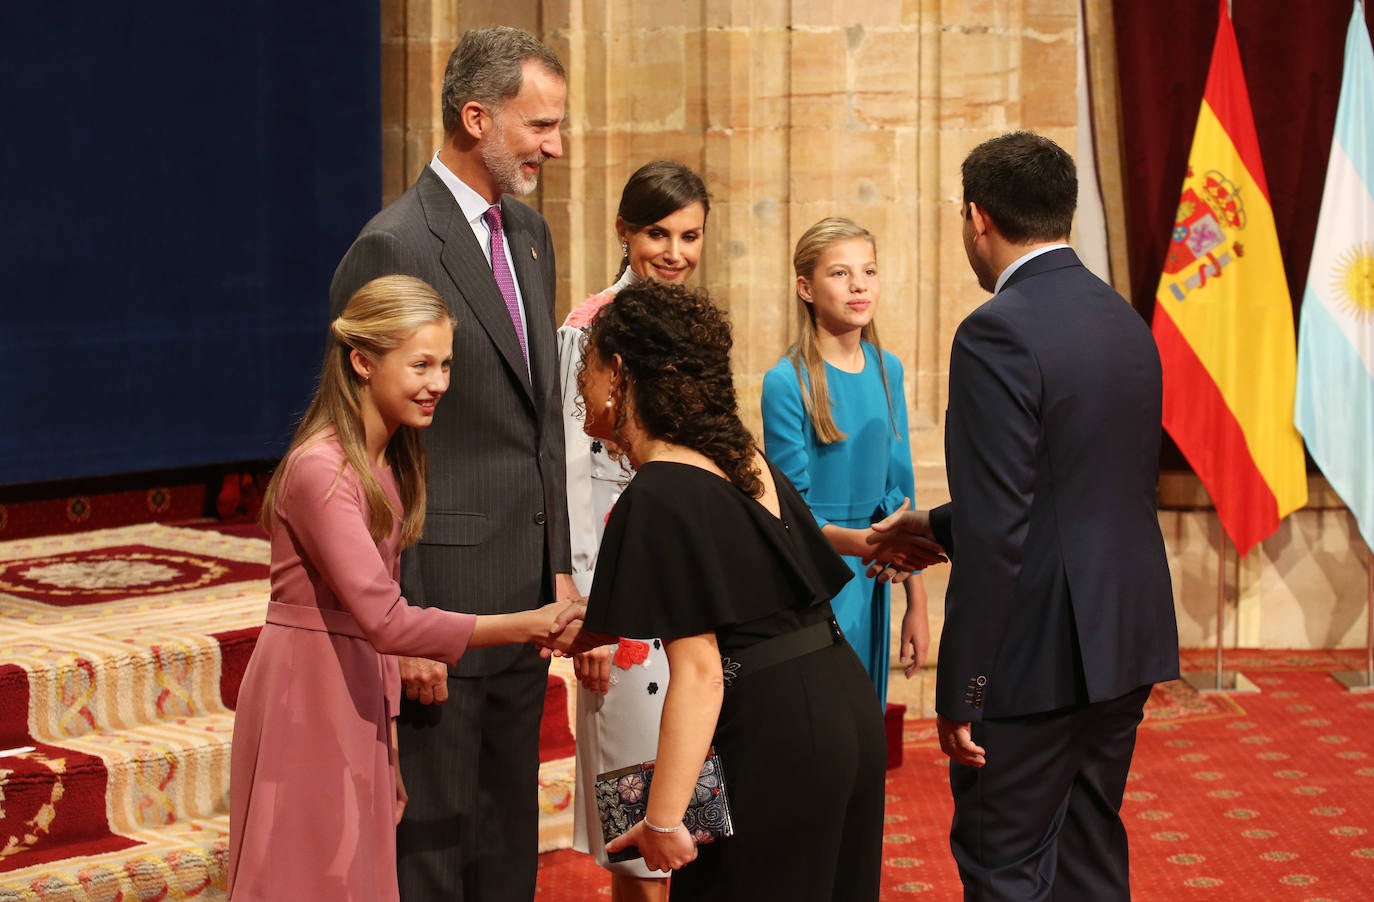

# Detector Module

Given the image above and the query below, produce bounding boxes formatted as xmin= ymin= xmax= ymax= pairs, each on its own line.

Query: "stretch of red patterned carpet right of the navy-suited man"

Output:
xmin=1125 ymin=652 xmax=1374 ymax=901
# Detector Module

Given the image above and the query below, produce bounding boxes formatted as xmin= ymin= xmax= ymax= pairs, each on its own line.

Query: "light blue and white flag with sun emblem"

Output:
xmin=1294 ymin=0 xmax=1374 ymax=549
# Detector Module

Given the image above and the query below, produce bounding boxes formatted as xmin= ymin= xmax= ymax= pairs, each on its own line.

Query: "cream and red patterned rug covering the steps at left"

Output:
xmin=0 ymin=524 xmax=573 ymax=902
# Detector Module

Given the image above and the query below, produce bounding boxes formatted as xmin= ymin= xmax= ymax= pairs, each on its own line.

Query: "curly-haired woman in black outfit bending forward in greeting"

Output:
xmin=578 ymin=282 xmax=885 ymax=902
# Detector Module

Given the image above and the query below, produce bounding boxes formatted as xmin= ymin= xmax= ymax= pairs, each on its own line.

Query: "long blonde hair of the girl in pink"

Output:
xmin=262 ymin=275 xmax=456 ymax=547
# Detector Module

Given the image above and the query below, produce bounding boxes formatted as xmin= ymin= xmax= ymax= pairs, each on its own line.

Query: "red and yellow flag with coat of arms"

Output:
xmin=1151 ymin=0 xmax=1307 ymax=556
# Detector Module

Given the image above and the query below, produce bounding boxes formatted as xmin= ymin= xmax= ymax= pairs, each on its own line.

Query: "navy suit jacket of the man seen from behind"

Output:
xmin=932 ymin=248 xmax=1179 ymax=721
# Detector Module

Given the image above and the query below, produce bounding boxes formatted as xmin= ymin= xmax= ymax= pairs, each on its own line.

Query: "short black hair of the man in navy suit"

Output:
xmin=962 ymin=132 xmax=1079 ymax=245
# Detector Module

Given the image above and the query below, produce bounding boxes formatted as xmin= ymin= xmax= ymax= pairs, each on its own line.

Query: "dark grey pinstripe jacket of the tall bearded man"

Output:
xmin=330 ymin=165 xmax=570 ymax=675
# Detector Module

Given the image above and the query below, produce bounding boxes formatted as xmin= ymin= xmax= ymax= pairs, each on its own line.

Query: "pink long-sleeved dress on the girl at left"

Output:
xmin=228 ymin=432 xmax=475 ymax=902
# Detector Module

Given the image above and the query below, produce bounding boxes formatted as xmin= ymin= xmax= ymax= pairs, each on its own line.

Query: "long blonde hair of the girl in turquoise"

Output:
xmin=787 ymin=216 xmax=897 ymax=444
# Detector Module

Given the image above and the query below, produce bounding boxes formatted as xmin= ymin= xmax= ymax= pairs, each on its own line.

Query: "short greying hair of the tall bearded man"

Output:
xmin=440 ymin=25 xmax=567 ymax=133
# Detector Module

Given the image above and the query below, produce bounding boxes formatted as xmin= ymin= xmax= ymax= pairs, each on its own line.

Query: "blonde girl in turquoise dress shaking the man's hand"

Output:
xmin=763 ymin=217 xmax=930 ymax=707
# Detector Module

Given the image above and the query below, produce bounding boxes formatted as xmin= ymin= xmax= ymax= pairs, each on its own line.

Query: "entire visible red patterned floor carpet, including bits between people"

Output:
xmin=537 ymin=652 xmax=1374 ymax=902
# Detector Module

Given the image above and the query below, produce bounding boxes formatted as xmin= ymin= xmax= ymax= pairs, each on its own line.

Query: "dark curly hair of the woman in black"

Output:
xmin=587 ymin=279 xmax=763 ymax=498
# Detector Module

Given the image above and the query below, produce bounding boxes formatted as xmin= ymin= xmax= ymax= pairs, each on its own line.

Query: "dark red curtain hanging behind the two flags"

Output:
xmin=1113 ymin=0 xmax=1370 ymax=319
